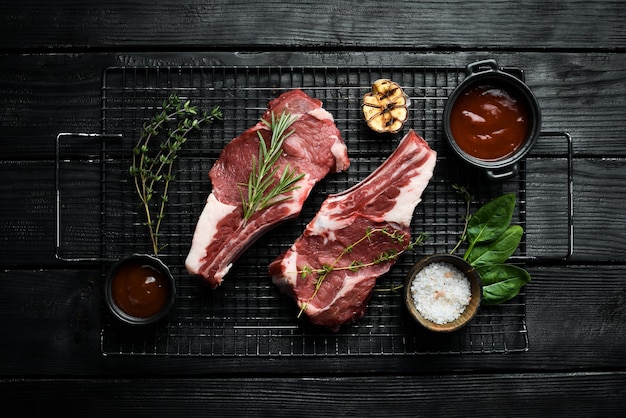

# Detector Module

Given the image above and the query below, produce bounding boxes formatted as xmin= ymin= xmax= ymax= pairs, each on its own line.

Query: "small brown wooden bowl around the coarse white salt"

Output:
xmin=404 ymin=254 xmax=482 ymax=332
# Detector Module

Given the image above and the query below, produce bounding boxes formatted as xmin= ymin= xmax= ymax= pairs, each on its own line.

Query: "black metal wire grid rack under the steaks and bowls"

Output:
xmin=59 ymin=67 xmax=571 ymax=356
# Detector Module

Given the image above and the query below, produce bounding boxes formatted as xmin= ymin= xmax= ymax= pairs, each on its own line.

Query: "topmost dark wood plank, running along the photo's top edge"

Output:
xmin=0 ymin=0 xmax=626 ymax=51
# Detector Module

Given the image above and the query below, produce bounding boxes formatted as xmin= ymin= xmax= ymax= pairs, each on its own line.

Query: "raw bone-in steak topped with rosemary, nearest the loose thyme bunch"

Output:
xmin=185 ymin=90 xmax=350 ymax=288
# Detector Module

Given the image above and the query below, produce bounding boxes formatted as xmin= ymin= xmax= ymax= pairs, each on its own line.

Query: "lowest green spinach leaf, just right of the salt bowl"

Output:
xmin=479 ymin=264 xmax=530 ymax=305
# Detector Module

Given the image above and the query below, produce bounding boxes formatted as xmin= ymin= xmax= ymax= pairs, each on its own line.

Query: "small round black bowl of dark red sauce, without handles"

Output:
xmin=104 ymin=254 xmax=176 ymax=325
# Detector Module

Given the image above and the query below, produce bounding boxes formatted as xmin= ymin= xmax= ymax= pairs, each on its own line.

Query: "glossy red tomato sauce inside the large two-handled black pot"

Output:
xmin=450 ymin=85 xmax=529 ymax=160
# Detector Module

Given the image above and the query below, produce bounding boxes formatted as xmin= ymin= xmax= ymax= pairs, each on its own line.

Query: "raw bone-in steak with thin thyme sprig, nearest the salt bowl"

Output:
xmin=269 ymin=130 xmax=436 ymax=331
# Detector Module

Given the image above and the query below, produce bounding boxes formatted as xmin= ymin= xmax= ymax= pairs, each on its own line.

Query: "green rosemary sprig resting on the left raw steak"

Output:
xmin=239 ymin=111 xmax=304 ymax=222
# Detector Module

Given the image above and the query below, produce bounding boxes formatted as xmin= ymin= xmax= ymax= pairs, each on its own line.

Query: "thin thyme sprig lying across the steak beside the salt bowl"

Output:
xmin=298 ymin=227 xmax=426 ymax=318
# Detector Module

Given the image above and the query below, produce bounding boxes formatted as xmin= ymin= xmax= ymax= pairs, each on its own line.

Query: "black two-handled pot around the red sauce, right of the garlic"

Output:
xmin=443 ymin=60 xmax=541 ymax=180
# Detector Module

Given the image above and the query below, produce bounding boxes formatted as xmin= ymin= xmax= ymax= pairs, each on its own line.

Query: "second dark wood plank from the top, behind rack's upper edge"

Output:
xmin=0 ymin=51 xmax=626 ymax=159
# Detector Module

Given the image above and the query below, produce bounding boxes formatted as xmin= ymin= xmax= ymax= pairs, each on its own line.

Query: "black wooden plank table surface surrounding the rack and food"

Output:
xmin=0 ymin=0 xmax=626 ymax=416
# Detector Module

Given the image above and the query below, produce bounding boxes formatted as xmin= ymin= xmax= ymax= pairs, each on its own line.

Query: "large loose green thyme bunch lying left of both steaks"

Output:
xmin=129 ymin=94 xmax=223 ymax=255
